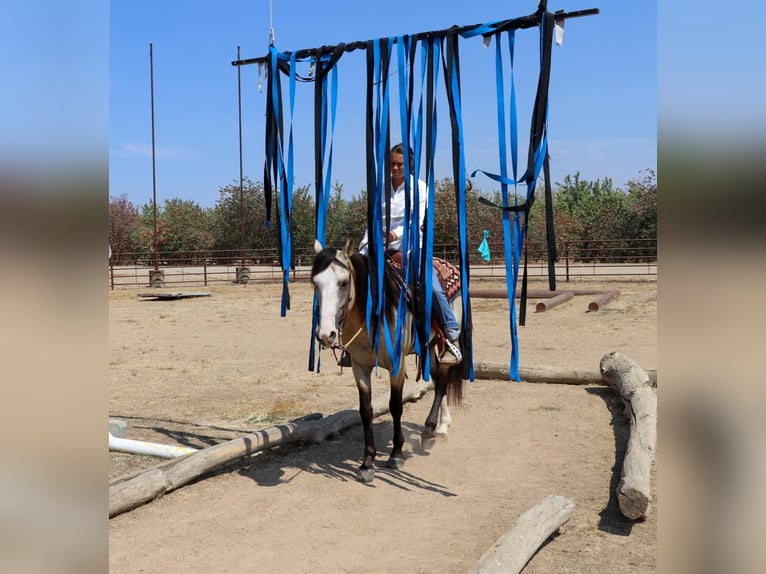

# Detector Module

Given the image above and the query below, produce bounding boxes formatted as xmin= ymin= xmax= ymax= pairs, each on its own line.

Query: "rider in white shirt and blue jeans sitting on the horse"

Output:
xmin=359 ymin=144 xmax=463 ymax=365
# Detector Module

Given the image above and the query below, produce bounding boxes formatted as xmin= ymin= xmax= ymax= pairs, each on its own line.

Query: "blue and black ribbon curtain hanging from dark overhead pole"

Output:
xmin=249 ymin=6 xmax=598 ymax=380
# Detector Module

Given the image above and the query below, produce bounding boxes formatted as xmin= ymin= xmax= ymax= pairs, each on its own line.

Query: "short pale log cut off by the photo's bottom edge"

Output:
xmin=468 ymin=495 xmax=575 ymax=574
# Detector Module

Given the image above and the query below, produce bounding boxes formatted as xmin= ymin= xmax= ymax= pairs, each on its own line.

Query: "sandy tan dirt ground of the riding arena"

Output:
xmin=109 ymin=279 xmax=657 ymax=574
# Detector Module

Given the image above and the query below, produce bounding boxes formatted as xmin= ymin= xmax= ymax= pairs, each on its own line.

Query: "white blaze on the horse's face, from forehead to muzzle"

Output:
xmin=313 ymin=263 xmax=351 ymax=347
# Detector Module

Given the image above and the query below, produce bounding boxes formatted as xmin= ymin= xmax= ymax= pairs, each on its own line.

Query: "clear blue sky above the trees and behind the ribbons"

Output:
xmin=109 ymin=0 xmax=657 ymax=207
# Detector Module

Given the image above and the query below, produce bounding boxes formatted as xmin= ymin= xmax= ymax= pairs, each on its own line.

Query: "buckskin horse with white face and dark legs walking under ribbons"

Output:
xmin=311 ymin=241 xmax=464 ymax=483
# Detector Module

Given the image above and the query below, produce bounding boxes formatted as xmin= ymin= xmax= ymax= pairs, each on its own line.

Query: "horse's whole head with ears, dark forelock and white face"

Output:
xmin=311 ymin=240 xmax=354 ymax=347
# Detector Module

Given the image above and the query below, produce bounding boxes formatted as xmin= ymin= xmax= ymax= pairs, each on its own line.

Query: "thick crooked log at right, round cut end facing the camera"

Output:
xmin=600 ymin=352 xmax=657 ymax=520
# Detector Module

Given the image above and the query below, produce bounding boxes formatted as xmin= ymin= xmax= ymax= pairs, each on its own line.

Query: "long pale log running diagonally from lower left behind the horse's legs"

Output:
xmin=109 ymin=381 xmax=433 ymax=518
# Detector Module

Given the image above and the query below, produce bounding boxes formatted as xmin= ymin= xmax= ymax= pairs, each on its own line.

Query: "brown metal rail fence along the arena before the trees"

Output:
xmin=109 ymin=239 xmax=657 ymax=289
